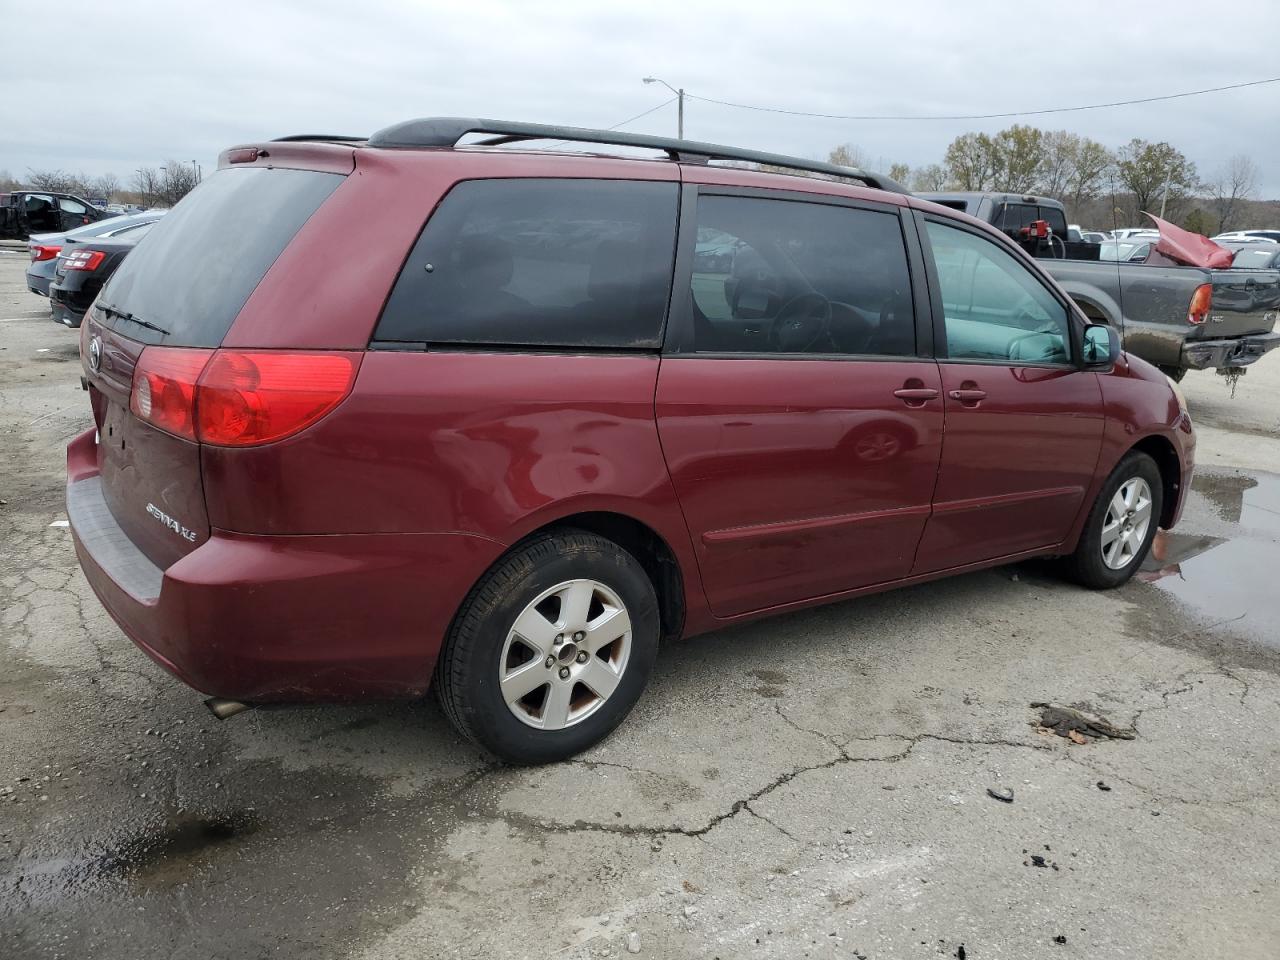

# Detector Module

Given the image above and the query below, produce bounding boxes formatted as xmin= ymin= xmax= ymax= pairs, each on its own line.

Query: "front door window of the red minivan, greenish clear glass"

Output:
xmin=928 ymin=221 xmax=1071 ymax=364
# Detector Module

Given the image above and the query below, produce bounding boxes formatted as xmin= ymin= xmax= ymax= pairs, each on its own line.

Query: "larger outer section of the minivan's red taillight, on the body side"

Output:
xmin=197 ymin=349 xmax=360 ymax=447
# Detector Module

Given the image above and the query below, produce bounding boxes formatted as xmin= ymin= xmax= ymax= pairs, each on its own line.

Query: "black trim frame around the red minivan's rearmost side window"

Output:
xmin=367 ymin=173 xmax=686 ymax=356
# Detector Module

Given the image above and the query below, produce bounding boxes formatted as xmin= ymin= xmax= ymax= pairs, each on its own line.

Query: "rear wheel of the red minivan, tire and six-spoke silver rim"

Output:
xmin=435 ymin=530 xmax=659 ymax=764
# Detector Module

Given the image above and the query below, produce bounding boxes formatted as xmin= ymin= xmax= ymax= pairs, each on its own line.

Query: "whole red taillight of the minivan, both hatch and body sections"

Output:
xmin=129 ymin=347 xmax=361 ymax=447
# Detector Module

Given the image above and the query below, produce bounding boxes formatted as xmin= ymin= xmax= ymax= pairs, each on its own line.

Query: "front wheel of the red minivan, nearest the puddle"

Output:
xmin=1064 ymin=451 xmax=1164 ymax=590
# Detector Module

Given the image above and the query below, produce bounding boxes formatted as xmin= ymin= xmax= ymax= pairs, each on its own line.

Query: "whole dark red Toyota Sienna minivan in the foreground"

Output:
xmin=67 ymin=118 xmax=1194 ymax=763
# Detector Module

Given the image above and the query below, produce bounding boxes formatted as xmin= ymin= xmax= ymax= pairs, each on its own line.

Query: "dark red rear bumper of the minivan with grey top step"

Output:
xmin=67 ymin=430 xmax=504 ymax=703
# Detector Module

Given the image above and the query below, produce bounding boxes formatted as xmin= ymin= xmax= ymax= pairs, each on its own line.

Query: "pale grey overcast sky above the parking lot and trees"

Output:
xmin=10 ymin=0 xmax=1280 ymax=198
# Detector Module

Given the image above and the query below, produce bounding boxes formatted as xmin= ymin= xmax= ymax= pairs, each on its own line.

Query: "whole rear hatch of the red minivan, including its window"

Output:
xmin=81 ymin=166 xmax=343 ymax=567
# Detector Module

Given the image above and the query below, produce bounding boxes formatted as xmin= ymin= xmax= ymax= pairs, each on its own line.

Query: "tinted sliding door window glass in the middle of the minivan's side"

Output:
xmin=691 ymin=196 xmax=915 ymax=356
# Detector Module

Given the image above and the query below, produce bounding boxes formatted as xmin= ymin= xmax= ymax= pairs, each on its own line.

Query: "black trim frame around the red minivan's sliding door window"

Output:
xmin=662 ymin=183 xmax=933 ymax=364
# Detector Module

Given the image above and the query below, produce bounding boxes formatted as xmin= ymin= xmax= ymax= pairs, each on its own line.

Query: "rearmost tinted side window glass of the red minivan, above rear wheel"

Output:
xmin=374 ymin=179 xmax=677 ymax=348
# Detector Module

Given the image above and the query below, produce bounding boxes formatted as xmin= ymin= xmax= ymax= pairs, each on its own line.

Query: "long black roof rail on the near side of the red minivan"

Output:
xmin=363 ymin=116 xmax=908 ymax=193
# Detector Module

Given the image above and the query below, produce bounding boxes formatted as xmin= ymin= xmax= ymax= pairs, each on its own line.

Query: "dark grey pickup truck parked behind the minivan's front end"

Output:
xmin=916 ymin=193 xmax=1280 ymax=380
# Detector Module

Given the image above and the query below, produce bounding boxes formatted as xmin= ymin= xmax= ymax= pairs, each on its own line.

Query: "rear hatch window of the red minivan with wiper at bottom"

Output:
xmin=99 ymin=168 xmax=343 ymax=347
